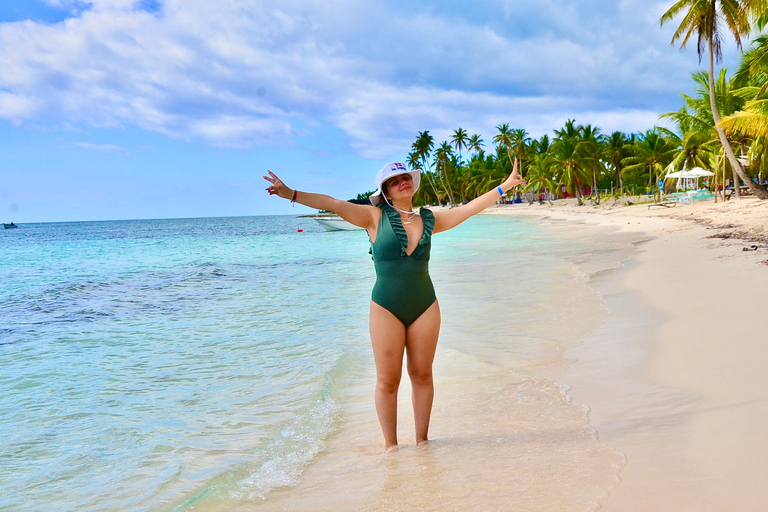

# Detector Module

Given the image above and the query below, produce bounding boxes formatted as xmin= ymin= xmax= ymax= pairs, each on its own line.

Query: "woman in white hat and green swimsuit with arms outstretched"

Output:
xmin=264 ymin=159 xmax=525 ymax=451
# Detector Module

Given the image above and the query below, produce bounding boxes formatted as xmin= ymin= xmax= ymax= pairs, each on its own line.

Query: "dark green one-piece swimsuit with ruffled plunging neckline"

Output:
xmin=370 ymin=204 xmax=437 ymax=327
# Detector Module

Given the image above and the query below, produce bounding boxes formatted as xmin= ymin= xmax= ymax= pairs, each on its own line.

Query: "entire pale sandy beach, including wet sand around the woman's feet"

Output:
xmin=201 ymin=199 xmax=768 ymax=512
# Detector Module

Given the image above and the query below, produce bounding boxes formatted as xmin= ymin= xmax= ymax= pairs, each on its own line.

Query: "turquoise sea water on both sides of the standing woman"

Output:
xmin=0 ymin=216 xmax=620 ymax=512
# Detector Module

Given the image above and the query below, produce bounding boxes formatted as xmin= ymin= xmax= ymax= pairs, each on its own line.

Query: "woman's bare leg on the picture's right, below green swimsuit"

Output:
xmin=405 ymin=301 xmax=440 ymax=445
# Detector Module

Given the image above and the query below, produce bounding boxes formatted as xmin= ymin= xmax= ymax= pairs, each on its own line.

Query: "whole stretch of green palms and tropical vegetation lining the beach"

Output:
xmin=374 ymin=0 xmax=768 ymax=205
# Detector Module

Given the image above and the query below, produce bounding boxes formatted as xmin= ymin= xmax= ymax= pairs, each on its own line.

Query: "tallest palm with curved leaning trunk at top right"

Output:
xmin=660 ymin=0 xmax=768 ymax=199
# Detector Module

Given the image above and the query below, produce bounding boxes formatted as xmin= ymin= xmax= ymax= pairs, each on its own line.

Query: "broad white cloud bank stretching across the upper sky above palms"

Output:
xmin=0 ymin=0 xmax=744 ymax=158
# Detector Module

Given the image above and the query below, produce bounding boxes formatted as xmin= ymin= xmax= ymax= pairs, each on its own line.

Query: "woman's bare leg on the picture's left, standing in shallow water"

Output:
xmin=369 ymin=301 xmax=405 ymax=450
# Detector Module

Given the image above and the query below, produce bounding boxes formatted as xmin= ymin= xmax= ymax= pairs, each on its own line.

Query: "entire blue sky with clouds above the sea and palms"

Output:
xmin=0 ymin=0 xmax=737 ymax=222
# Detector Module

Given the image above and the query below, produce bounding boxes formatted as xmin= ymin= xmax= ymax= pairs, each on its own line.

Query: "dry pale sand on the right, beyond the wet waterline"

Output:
xmin=488 ymin=195 xmax=768 ymax=511
